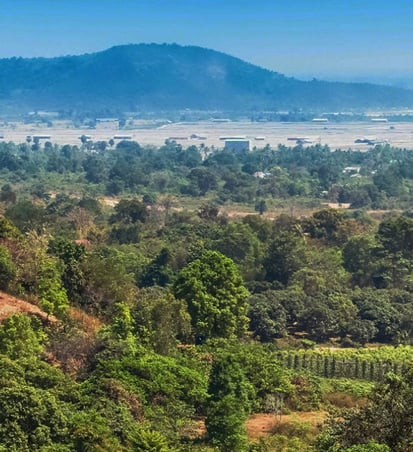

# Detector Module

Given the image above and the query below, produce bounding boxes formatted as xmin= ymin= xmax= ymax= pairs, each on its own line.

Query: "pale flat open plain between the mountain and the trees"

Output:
xmin=0 ymin=121 xmax=413 ymax=150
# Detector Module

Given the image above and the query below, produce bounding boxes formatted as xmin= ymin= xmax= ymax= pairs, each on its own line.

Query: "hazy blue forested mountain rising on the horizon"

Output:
xmin=0 ymin=44 xmax=413 ymax=113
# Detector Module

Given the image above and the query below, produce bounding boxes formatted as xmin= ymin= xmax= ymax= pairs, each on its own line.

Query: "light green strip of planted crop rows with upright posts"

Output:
xmin=278 ymin=346 xmax=413 ymax=381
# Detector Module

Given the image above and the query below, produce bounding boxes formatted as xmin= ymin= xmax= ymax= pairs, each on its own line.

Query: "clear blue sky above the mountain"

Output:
xmin=0 ymin=0 xmax=413 ymax=86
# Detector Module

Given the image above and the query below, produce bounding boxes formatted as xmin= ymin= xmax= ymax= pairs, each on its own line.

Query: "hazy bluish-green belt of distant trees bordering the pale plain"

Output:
xmin=0 ymin=140 xmax=413 ymax=212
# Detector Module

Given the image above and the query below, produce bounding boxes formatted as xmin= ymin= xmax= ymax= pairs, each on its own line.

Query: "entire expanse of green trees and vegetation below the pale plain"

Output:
xmin=0 ymin=142 xmax=413 ymax=452
